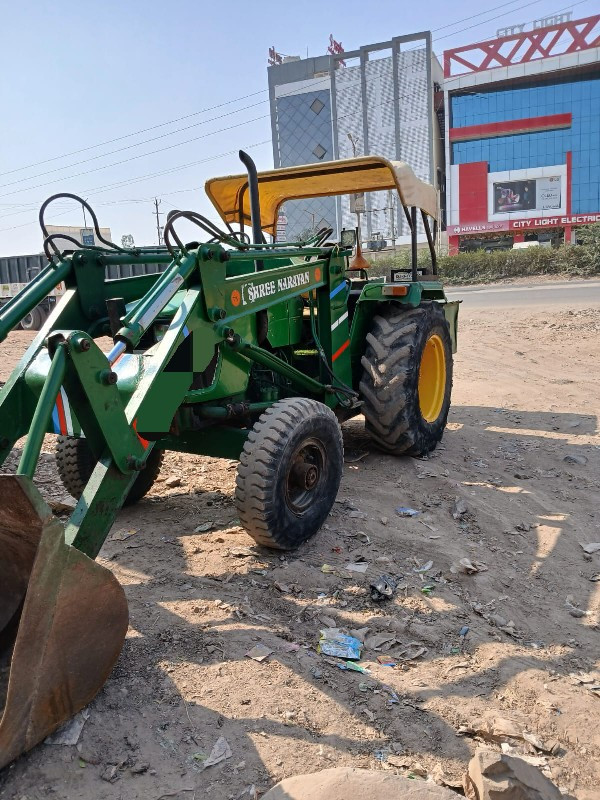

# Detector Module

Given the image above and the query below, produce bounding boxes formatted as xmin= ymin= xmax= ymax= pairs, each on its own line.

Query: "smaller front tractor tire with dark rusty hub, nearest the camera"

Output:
xmin=235 ymin=397 xmax=344 ymax=550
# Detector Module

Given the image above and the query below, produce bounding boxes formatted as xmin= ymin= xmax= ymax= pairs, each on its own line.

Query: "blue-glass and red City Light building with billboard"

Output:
xmin=444 ymin=13 xmax=600 ymax=252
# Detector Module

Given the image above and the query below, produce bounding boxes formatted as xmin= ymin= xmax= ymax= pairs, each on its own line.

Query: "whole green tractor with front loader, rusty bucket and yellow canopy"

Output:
xmin=0 ymin=153 xmax=457 ymax=767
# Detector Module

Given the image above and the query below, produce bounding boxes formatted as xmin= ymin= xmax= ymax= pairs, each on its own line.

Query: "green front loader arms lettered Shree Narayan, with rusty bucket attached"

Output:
xmin=0 ymin=225 xmax=351 ymax=766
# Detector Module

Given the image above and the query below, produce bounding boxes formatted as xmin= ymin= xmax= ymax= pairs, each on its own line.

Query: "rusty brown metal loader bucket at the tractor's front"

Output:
xmin=0 ymin=475 xmax=128 ymax=768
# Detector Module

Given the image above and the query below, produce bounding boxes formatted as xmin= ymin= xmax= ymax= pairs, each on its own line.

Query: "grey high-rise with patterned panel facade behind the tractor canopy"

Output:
xmin=268 ymin=31 xmax=444 ymax=240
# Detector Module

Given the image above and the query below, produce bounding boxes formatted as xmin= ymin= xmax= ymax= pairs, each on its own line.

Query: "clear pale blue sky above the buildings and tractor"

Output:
xmin=0 ymin=0 xmax=598 ymax=255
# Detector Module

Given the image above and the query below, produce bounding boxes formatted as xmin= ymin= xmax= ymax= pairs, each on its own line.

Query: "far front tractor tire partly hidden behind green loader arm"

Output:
xmin=56 ymin=436 xmax=163 ymax=506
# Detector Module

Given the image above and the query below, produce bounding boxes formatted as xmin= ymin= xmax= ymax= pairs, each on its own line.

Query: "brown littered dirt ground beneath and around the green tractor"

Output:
xmin=0 ymin=300 xmax=600 ymax=800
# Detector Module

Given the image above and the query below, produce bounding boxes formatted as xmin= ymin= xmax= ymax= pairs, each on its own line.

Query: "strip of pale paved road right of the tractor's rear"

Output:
xmin=447 ymin=280 xmax=600 ymax=309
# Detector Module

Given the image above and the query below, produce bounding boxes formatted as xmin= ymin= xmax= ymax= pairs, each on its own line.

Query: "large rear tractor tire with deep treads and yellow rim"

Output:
xmin=360 ymin=302 xmax=452 ymax=456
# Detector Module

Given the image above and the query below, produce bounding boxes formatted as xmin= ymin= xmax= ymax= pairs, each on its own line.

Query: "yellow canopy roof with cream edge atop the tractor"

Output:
xmin=205 ymin=156 xmax=439 ymax=235
